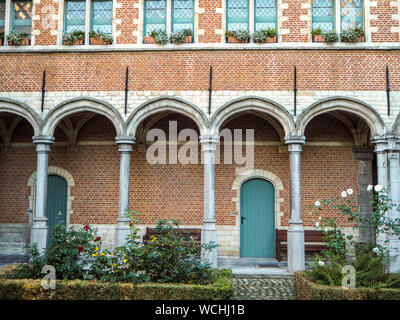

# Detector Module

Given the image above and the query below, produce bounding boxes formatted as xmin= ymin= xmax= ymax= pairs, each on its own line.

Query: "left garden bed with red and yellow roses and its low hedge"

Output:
xmin=0 ymin=215 xmax=233 ymax=300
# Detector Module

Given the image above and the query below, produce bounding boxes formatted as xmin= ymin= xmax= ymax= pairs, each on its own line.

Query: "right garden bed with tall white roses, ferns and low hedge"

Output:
xmin=294 ymin=185 xmax=400 ymax=300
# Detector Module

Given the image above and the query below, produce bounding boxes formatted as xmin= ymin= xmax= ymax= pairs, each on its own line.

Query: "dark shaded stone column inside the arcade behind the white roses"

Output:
xmin=353 ymin=146 xmax=374 ymax=244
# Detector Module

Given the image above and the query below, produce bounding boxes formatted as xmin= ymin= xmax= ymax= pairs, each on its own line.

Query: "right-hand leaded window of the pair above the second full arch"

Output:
xmin=172 ymin=0 xmax=194 ymax=32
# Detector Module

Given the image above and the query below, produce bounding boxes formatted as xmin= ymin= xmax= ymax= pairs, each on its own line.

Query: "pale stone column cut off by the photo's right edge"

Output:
xmin=388 ymin=136 xmax=400 ymax=272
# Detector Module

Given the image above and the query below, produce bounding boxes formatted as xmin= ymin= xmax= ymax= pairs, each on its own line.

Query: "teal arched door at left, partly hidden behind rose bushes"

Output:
xmin=46 ymin=175 xmax=68 ymax=243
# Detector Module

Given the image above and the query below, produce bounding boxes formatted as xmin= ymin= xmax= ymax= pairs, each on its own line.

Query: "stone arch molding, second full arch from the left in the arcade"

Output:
xmin=126 ymin=96 xmax=209 ymax=136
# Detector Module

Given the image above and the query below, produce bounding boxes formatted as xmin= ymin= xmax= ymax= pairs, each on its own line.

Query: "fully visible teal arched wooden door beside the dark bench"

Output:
xmin=240 ymin=178 xmax=275 ymax=258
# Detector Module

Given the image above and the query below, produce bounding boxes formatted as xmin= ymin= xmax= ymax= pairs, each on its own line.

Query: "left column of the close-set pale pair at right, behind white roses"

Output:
xmin=371 ymin=136 xmax=388 ymax=246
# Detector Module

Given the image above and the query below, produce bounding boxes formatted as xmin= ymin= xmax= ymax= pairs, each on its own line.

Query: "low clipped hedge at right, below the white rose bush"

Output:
xmin=294 ymin=271 xmax=400 ymax=300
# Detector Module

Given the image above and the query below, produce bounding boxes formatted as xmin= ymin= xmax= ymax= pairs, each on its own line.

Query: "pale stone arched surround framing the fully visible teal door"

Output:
xmin=232 ymin=169 xmax=284 ymax=229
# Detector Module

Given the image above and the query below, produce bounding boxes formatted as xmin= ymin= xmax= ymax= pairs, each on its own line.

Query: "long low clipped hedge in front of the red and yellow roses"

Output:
xmin=0 ymin=266 xmax=233 ymax=300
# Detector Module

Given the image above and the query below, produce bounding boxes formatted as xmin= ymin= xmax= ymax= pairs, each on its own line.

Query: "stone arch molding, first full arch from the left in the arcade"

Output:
xmin=42 ymin=97 xmax=125 ymax=136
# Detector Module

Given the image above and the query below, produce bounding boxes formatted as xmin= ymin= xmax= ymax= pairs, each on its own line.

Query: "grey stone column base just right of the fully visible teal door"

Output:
xmin=287 ymin=224 xmax=305 ymax=273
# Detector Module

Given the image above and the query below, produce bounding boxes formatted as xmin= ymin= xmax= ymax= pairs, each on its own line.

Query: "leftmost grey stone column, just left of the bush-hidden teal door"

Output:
xmin=31 ymin=136 xmax=54 ymax=252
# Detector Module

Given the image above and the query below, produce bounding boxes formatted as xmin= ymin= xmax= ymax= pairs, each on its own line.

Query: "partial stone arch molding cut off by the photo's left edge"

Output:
xmin=0 ymin=98 xmax=41 ymax=136
